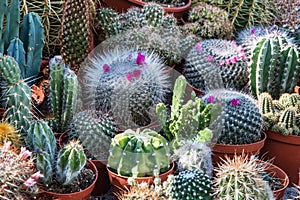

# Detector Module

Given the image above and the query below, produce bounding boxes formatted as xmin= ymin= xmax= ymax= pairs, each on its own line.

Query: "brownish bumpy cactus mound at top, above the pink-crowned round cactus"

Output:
xmin=183 ymin=2 xmax=233 ymax=39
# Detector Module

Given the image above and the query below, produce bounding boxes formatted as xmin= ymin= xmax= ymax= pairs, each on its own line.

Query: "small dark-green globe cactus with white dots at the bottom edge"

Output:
xmin=171 ymin=170 xmax=213 ymax=200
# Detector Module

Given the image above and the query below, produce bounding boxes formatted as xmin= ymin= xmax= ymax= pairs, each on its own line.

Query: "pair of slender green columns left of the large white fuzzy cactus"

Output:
xmin=49 ymin=56 xmax=79 ymax=132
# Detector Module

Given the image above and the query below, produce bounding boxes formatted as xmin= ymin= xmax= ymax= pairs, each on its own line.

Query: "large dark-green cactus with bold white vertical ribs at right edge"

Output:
xmin=250 ymin=31 xmax=300 ymax=99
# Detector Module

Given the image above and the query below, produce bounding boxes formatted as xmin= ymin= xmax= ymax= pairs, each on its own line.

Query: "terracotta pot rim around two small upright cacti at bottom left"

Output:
xmin=43 ymin=160 xmax=98 ymax=200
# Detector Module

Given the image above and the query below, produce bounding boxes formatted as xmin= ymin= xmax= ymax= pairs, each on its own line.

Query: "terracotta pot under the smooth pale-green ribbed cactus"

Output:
xmin=106 ymin=162 xmax=174 ymax=199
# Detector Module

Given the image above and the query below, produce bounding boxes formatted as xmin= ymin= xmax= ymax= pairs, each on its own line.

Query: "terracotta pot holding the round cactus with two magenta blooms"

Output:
xmin=210 ymin=132 xmax=267 ymax=166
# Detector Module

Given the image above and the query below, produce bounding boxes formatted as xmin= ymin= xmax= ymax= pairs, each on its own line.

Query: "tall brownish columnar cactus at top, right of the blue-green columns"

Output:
xmin=60 ymin=0 xmax=94 ymax=74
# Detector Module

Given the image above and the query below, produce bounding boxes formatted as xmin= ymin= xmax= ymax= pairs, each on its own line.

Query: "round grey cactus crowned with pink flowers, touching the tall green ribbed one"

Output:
xmin=184 ymin=39 xmax=249 ymax=90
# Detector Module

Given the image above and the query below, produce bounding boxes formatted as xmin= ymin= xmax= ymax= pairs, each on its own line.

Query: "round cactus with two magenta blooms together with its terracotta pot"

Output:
xmin=202 ymin=89 xmax=266 ymax=164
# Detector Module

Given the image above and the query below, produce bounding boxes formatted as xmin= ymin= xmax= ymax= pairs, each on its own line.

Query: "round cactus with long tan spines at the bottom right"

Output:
xmin=214 ymin=155 xmax=274 ymax=200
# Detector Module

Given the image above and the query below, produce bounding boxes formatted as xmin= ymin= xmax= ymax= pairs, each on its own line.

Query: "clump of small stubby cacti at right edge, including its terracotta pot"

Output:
xmin=259 ymin=93 xmax=300 ymax=184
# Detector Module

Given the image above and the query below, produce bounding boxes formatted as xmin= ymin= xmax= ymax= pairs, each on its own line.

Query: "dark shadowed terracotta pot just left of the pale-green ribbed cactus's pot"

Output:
xmin=91 ymin=160 xmax=110 ymax=196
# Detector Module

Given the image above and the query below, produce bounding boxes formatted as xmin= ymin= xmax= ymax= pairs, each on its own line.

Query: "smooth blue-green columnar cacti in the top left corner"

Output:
xmin=0 ymin=0 xmax=44 ymax=79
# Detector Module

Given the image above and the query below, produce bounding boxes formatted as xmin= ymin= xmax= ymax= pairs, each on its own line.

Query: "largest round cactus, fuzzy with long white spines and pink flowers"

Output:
xmin=79 ymin=48 xmax=169 ymax=129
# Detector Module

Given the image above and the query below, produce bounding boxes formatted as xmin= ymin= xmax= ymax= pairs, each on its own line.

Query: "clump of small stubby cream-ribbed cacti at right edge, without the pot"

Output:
xmin=258 ymin=93 xmax=300 ymax=135
